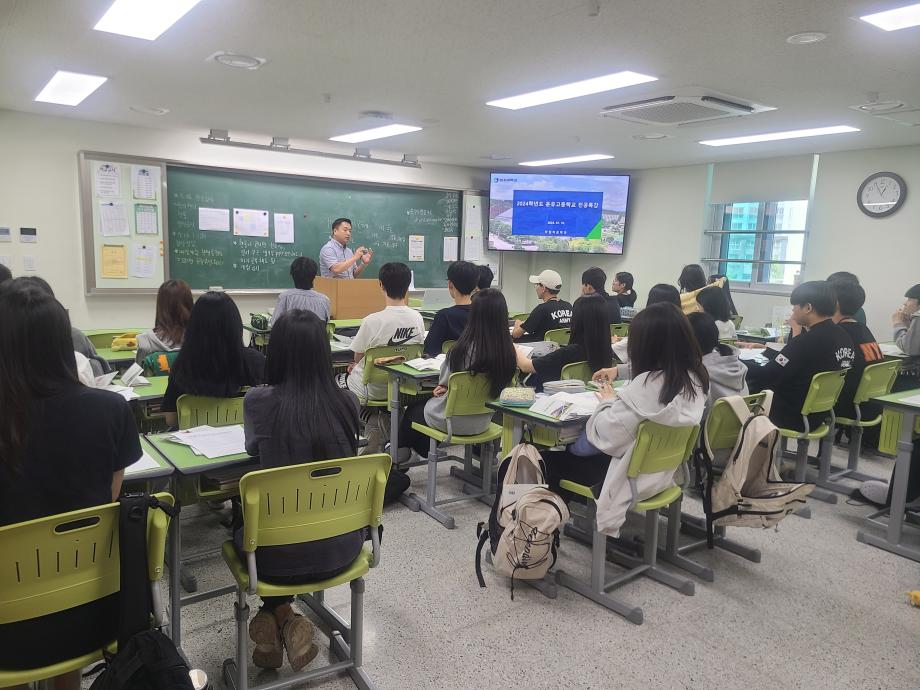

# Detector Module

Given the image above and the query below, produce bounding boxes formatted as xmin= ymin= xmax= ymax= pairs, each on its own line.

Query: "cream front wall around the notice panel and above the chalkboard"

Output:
xmin=0 ymin=110 xmax=488 ymax=328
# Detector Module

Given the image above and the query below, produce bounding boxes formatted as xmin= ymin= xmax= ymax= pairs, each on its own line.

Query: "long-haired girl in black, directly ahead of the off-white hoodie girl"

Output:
xmin=516 ymin=295 xmax=613 ymax=392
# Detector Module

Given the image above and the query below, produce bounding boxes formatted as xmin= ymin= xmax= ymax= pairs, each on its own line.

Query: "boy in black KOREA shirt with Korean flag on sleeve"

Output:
xmin=745 ymin=280 xmax=856 ymax=431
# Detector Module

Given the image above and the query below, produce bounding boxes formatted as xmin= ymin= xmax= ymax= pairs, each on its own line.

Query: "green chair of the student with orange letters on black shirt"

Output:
xmin=817 ymin=359 xmax=900 ymax=494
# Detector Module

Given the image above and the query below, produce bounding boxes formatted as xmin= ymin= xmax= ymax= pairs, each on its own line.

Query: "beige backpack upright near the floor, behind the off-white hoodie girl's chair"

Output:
xmin=476 ymin=443 xmax=569 ymax=600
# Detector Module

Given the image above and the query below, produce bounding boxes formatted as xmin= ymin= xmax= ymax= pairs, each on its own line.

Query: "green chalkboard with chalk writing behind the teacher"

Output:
xmin=166 ymin=165 xmax=460 ymax=289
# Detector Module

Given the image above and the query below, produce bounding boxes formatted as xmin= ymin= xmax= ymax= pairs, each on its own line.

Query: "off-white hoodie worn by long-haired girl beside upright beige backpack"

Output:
xmin=586 ymin=372 xmax=706 ymax=537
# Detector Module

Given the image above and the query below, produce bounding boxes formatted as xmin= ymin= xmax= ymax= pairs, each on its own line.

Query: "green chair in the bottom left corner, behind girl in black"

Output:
xmin=0 ymin=493 xmax=173 ymax=687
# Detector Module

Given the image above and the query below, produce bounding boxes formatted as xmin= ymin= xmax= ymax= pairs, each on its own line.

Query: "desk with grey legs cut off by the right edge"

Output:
xmin=856 ymin=388 xmax=920 ymax=562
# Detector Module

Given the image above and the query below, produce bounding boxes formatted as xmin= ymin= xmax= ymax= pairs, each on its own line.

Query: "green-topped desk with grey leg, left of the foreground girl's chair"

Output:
xmin=147 ymin=432 xmax=258 ymax=648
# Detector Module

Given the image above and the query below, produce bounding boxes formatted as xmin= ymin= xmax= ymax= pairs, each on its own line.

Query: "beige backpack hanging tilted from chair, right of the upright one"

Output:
xmin=697 ymin=391 xmax=815 ymax=543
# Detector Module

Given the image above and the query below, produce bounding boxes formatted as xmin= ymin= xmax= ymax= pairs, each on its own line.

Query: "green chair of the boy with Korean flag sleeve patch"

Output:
xmin=778 ymin=369 xmax=847 ymax=510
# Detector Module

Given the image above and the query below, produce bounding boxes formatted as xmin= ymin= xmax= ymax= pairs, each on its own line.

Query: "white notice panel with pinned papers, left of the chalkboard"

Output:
xmin=79 ymin=153 xmax=166 ymax=293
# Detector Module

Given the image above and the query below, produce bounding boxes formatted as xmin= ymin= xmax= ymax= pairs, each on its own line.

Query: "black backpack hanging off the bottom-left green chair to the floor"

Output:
xmin=90 ymin=494 xmax=194 ymax=690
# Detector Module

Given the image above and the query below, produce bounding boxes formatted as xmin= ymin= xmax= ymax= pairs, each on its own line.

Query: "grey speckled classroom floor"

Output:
xmin=99 ymin=450 xmax=920 ymax=690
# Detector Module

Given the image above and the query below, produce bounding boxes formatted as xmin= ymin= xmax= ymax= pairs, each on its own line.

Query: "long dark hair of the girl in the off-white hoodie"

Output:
xmin=626 ymin=303 xmax=709 ymax=405
